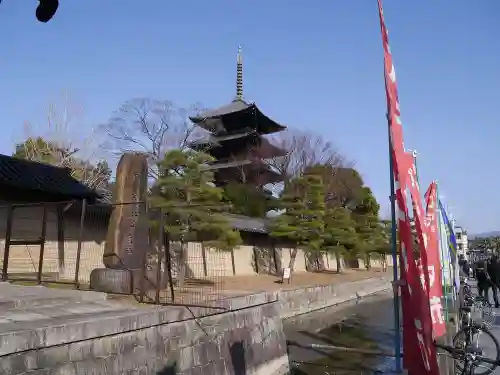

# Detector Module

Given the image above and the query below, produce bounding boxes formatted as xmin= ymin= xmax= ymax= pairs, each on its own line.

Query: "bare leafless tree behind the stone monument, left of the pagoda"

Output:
xmin=101 ymin=98 xmax=208 ymax=179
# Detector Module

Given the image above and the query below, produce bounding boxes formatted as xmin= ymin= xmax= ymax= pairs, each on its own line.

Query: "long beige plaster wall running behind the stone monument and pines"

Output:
xmin=0 ymin=206 xmax=392 ymax=284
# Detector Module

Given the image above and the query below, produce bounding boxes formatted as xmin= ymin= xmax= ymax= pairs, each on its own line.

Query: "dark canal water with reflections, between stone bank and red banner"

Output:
xmin=283 ymin=292 xmax=394 ymax=375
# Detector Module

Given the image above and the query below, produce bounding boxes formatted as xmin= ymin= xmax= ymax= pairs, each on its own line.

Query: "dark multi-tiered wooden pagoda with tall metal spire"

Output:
xmin=190 ymin=48 xmax=286 ymax=187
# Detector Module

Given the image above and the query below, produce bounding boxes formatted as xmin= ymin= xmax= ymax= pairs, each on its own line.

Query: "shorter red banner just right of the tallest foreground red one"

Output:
xmin=424 ymin=181 xmax=446 ymax=337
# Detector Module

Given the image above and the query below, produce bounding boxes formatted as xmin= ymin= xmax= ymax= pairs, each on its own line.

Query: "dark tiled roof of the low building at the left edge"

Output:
xmin=0 ymin=154 xmax=98 ymax=199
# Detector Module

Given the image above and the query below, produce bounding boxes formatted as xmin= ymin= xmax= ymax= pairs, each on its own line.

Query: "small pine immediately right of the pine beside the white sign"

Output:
xmin=323 ymin=207 xmax=358 ymax=273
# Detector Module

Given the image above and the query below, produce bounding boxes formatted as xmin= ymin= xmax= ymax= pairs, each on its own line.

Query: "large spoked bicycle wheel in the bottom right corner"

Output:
xmin=453 ymin=325 xmax=500 ymax=375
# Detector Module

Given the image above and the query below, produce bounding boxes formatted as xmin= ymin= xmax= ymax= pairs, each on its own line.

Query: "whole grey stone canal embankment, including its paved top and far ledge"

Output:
xmin=0 ymin=278 xmax=391 ymax=375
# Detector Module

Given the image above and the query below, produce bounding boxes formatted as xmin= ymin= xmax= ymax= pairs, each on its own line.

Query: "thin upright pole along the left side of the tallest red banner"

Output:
xmin=386 ymin=113 xmax=401 ymax=373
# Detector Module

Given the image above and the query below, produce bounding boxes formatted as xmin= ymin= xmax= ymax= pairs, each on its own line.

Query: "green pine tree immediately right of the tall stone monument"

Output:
xmin=151 ymin=150 xmax=241 ymax=287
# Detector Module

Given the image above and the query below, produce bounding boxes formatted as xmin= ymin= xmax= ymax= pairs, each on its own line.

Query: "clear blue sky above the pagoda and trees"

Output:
xmin=0 ymin=0 xmax=500 ymax=232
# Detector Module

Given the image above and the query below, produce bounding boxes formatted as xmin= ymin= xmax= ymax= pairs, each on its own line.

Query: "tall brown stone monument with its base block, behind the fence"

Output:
xmin=90 ymin=153 xmax=149 ymax=294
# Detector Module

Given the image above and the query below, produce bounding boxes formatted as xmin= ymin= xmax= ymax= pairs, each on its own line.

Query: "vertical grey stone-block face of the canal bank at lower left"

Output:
xmin=0 ymin=294 xmax=289 ymax=375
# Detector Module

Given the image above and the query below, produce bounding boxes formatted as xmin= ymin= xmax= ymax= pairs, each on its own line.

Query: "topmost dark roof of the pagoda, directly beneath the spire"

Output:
xmin=190 ymin=99 xmax=286 ymax=135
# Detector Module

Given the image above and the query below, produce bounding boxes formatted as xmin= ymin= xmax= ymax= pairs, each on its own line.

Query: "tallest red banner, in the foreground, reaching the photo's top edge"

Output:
xmin=378 ymin=0 xmax=439 ymax=375
